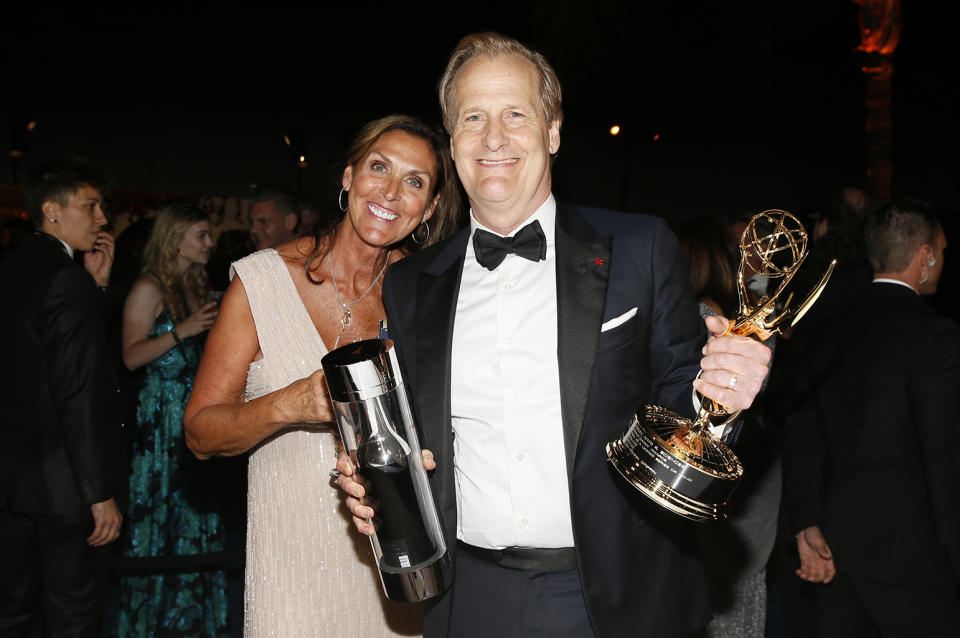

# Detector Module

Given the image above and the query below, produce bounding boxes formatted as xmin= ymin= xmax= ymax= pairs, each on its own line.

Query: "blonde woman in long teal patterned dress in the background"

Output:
xmin=117 ymin=205 xmax=228 ymax=638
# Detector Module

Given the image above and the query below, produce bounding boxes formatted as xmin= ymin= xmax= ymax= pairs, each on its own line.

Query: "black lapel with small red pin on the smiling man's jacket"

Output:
xmin=556 ymin=202 xmax=611 ymax=481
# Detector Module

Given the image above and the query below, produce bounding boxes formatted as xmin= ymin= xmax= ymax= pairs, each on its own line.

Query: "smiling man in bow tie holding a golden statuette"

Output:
xmin=338 ymin=34 xmax=769 ymax=638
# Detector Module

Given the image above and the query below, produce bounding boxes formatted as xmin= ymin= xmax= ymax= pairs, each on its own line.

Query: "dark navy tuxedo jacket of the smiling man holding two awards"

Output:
xmin=383 ymin=202 xmax=710 ymax=637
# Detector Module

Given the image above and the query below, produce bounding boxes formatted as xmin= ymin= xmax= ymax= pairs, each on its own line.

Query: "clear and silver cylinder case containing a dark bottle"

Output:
xmin=322 ymin=339 xmax=453 ymax=602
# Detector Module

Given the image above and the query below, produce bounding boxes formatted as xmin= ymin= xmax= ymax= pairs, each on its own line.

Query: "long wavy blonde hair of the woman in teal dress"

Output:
xmin=142 ymin=204 xmax=210 ymax=323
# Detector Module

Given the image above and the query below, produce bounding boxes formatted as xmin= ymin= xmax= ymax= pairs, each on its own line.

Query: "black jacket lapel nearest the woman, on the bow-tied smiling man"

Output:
xmin=416 ymin=228 xmax=470 ymax=520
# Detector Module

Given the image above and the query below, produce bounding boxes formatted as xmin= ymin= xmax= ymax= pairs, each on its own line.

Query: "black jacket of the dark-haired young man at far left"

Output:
xmin=0 ymin=233 xmax=126 ymax=515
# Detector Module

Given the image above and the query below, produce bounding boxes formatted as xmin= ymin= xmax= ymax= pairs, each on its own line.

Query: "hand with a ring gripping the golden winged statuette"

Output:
xmin=693 ymin=317 xmax=770 ymax=412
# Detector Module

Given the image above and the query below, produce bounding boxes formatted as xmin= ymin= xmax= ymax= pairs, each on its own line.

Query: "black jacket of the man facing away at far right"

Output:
xmin=783 ymin=283 xmax=960 ymax=587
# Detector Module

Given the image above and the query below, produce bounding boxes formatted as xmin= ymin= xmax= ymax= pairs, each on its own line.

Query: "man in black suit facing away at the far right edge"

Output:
xmin=783 ymin=202 xmax=960 ymax=636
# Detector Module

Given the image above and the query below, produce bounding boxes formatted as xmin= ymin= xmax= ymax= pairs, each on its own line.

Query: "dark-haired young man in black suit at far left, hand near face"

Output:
xmin=0 ymin=159 xmax=125 ymax=637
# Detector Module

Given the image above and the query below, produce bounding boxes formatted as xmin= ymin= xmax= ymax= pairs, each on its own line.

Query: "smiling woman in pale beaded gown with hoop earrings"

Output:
xmin=185 ymin=116 xmax=460 ymax=638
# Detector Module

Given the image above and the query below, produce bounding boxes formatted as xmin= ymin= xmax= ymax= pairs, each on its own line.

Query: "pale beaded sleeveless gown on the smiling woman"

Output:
xmin=233 ymin=249 xmax=421 ymax=638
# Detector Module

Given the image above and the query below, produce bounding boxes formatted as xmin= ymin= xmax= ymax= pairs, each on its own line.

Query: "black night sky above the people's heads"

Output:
xmin=0 ymin=0 xmax=960 ymax=216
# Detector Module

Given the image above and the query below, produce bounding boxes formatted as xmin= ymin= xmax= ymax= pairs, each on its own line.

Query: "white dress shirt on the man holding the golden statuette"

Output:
xmin=450 ymin=195 xmax=573 ymax=548
